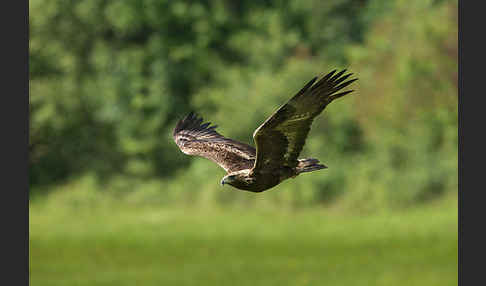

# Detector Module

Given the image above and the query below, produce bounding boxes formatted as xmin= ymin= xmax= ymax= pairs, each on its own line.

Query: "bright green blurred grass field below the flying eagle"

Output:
xmin=30 ymin=197 xmax=458 ymax=286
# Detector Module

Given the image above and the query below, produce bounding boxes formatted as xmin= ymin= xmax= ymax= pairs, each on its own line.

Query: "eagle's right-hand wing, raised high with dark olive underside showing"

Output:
xmin=252 ymin=70 xmax=357 ymax=172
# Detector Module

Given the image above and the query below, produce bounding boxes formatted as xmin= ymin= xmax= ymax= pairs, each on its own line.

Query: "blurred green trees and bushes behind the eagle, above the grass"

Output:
xmin=29 ymin=0 xmax=458 ymax=211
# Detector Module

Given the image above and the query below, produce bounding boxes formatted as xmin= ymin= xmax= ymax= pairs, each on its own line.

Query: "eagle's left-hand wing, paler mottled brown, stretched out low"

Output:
xmin=173 ymin=112 xmax=256 ymax=173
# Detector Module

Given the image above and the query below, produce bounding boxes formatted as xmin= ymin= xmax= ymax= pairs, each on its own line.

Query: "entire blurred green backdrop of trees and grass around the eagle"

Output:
xmin=29 ymin=0 xmax=458 ymax=285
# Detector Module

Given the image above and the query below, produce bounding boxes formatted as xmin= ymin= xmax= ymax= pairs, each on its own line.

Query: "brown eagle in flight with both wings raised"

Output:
xmin=173 ymin=69 xmax=357 ymax=193
